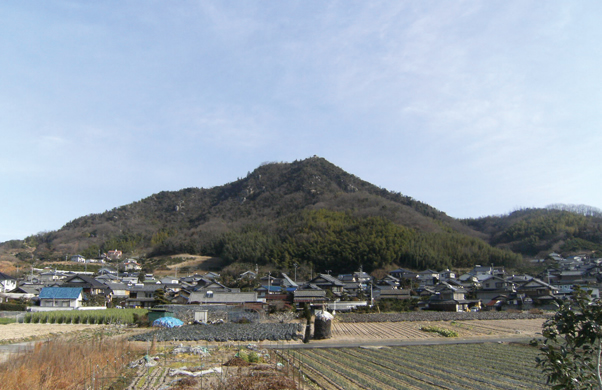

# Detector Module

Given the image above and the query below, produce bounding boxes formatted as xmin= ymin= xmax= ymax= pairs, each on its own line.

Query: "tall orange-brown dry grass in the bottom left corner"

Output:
xmin=0 ymin=336 xmax=140 ymax=390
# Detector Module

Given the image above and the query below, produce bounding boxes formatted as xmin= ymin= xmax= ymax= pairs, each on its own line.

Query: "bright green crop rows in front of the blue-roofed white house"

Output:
xmin=23 ymin=309 xmax=148 ymax=324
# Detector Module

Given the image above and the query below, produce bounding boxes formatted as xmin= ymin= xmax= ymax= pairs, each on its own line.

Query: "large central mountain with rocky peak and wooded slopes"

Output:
xmin=2 ymin=156 xmax=591 ymax=271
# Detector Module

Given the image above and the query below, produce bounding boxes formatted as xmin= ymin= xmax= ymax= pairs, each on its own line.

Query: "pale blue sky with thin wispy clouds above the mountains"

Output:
xmin=0 ymin=0 xmax=602 ymax=242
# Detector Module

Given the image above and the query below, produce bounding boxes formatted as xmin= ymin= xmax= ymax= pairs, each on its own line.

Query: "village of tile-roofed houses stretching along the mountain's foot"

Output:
xmin=0 ymin=250 xmax=602 ymax=312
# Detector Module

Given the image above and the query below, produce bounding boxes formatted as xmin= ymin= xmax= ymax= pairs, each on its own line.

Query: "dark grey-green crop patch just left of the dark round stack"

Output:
xmin=130 ymin=323 xmax=303 ymax=342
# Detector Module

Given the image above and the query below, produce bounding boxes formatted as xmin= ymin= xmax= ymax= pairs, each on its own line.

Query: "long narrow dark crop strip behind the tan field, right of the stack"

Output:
xmin=336 ymin=311 xmax=550 ymax=322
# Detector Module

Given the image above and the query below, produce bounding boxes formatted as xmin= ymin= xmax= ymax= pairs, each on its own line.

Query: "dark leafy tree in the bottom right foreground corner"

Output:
xmin=532 ymin=288 xmax=602 ymax=390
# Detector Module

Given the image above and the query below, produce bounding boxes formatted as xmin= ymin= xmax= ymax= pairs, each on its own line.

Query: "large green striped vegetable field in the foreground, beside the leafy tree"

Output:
xmin=286 ymin=344 xmax=549 ymax=390
